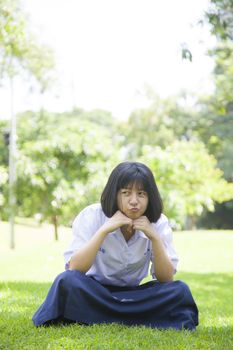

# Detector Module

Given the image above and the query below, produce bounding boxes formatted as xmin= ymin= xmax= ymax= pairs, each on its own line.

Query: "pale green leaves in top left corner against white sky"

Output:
xmin=0 ymin=0 xmax=55 ymax=92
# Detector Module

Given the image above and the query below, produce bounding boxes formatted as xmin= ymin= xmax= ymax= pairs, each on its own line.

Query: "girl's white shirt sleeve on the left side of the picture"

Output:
xmin=64 ymin=206 xmax=100 ymax=269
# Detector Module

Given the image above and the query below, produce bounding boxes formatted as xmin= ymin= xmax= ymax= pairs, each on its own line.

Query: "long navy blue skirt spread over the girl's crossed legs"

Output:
xmin=33 ymin=270 xmax=198 ymax=330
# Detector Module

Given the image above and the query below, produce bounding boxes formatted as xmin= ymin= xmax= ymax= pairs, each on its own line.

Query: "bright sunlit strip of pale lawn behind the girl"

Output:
xmin=0 ymin=223 xmax=233 ymax=281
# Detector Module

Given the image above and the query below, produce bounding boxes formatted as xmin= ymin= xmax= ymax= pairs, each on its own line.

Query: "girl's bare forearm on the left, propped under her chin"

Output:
xmin=69 ymin=211 xmax=132 ymax=272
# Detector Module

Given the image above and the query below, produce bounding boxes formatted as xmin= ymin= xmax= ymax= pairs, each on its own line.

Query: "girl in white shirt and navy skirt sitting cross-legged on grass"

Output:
xmin=33 ymin=162 xmax=198 ymax=330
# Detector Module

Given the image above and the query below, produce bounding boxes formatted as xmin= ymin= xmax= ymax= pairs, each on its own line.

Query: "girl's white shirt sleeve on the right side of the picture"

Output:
xmin=151 ymin=214 xmax=179 ymax=277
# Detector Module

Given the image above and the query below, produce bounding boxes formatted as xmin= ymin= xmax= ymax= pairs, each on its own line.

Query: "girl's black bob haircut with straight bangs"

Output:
xmin=101 ymin=162 xmax=163 ymax=222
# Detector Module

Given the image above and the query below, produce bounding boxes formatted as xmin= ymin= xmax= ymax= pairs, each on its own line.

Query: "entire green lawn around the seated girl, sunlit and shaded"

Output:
xmin=0 ymin=223 xmax=233 ymax=350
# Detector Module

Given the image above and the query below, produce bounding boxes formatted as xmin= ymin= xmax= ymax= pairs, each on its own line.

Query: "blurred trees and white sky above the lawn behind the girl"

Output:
xmin=0 ymin=0 xmax=233 ymax=248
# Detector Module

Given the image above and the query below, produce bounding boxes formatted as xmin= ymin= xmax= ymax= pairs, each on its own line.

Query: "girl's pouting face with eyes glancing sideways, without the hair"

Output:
xmin=117 ymin=183 xmax=148 ymax=220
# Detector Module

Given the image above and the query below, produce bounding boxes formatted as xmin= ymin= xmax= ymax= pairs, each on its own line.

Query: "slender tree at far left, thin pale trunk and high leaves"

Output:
xmin=0 ymin=0 xmax=54 ymax=248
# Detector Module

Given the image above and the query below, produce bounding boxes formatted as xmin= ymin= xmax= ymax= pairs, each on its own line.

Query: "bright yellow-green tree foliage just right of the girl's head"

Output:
xmin=141 ymin=141 xmax=233 ymax=225
